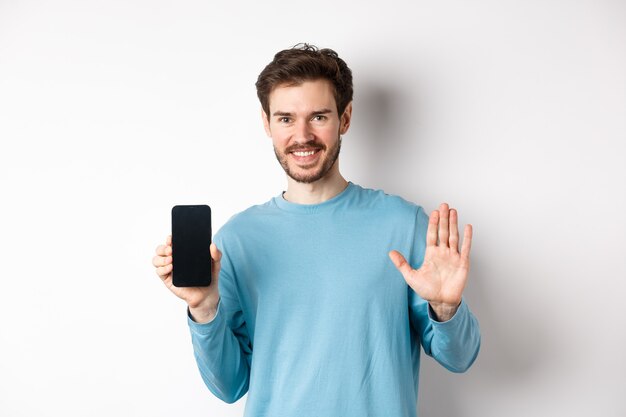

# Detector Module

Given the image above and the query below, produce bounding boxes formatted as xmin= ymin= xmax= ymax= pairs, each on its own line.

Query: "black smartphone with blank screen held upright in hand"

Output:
xmin=172 ymin=205 xmax=212 ymax=287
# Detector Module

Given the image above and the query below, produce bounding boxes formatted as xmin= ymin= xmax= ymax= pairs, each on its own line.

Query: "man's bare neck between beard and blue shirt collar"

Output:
xmin=283 ymin=161 xmax=348 ymax=204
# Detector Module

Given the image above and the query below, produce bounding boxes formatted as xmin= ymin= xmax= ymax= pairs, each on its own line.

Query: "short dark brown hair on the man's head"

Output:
xmin=256 ymin=43 xmax=352 ymax=117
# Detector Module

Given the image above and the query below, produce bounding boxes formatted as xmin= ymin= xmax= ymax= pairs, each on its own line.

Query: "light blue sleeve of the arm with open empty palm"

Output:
xmin=408 ymin=207 xmax=480 ymax=372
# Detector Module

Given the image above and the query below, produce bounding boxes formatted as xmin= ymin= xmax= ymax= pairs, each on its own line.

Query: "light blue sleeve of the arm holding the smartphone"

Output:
xmin=187 ymin=234 xmax=252 ymax=403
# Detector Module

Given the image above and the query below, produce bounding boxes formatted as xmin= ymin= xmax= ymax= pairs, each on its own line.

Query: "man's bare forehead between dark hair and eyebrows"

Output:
xmin=269 ymin=80 xmax=337 ymax=113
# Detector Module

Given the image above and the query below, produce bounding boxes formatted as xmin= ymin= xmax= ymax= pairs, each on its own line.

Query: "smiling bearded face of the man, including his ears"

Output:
xmin=263 ymin=80 xmax=352 ymax=183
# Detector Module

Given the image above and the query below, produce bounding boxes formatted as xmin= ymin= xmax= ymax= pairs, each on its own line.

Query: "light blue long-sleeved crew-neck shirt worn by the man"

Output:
xmin=188 ymin=183 xmax=480 ymax=417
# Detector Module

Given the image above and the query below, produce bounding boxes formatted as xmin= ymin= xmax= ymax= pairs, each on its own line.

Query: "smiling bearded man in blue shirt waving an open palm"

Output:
xmin=153 ymin=44 xmax=480 ymax=417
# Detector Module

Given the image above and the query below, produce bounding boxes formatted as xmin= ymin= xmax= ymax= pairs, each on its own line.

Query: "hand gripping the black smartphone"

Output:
xmin=152 ymin=235 xmax=222 ymax=323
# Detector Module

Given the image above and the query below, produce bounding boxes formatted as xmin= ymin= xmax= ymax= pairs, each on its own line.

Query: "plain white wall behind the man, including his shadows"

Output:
xmin=0 ymin=0 xmax=626 ymax=417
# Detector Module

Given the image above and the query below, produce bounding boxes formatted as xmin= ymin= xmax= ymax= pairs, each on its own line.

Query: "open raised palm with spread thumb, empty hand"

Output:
xmin=389 ymin=203 xmax=472 ymax=321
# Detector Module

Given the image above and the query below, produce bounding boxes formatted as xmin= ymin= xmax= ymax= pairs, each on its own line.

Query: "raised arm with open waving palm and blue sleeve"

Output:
xmin=389 ymin=203 xmax=480 ymax=372
